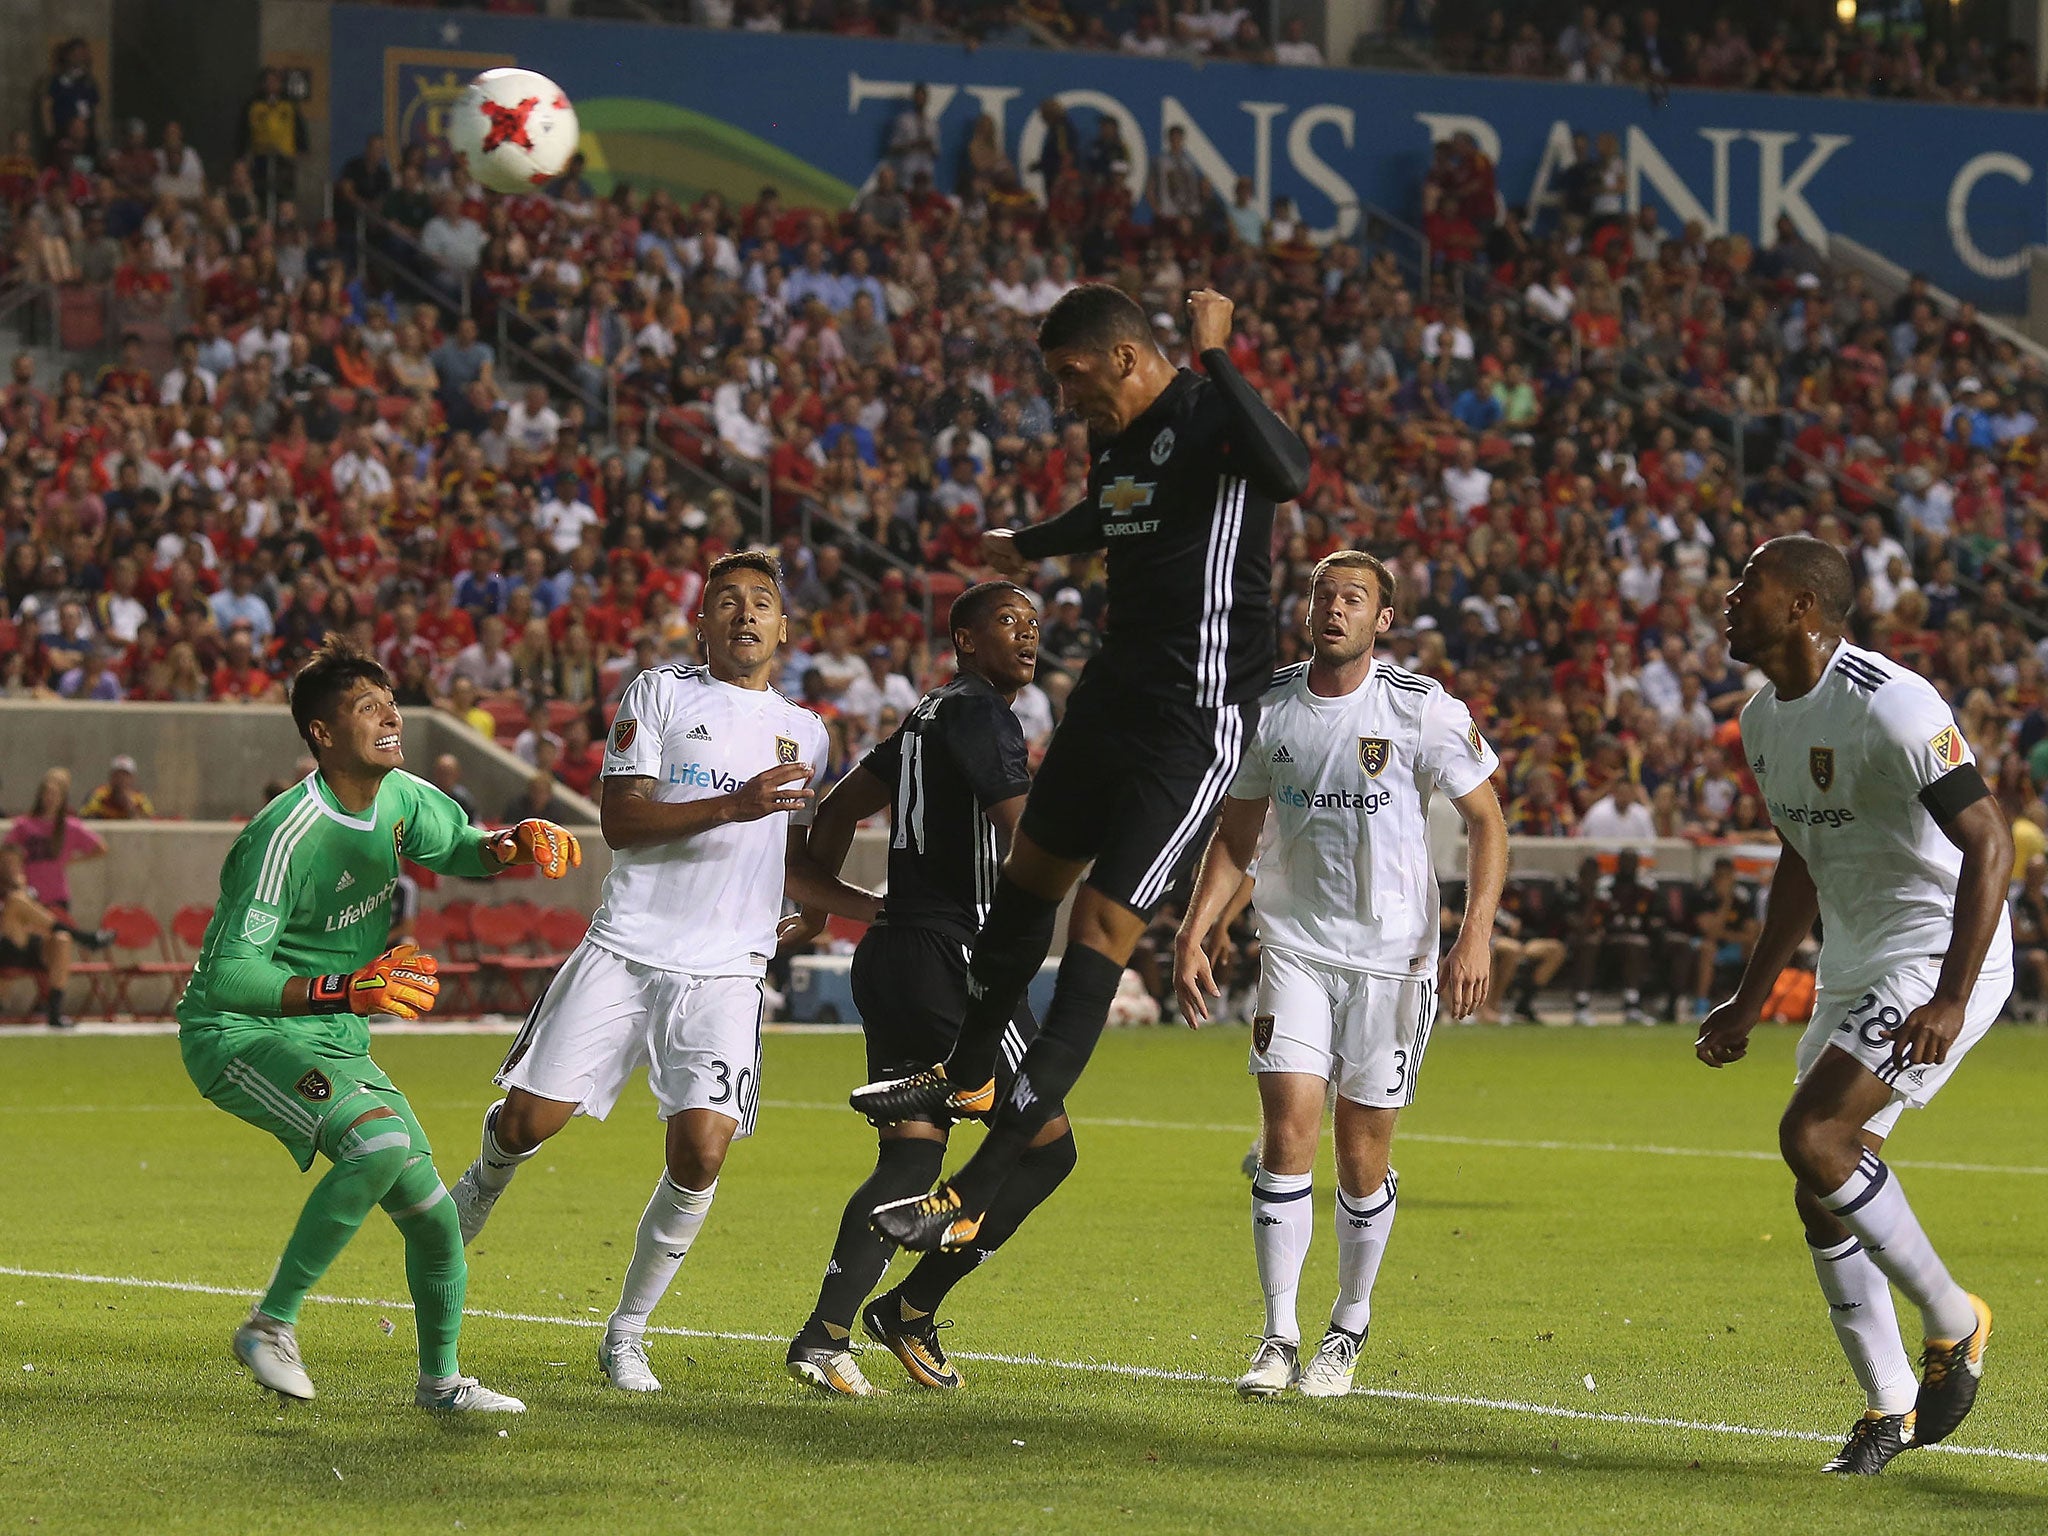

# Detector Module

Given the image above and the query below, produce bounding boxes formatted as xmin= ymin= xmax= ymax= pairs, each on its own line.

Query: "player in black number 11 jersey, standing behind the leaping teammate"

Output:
xmin=784 ymin=582 xmax=1073 ymax=1397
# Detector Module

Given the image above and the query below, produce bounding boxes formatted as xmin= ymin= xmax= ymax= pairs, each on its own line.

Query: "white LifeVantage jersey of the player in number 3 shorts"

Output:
xmin=1229 ymin=659 xmax=1499 ymax=977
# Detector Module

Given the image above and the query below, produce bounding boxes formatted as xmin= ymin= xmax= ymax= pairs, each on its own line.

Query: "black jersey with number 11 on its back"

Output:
xmin=860 ymin=672 xmax=1030 ymax=944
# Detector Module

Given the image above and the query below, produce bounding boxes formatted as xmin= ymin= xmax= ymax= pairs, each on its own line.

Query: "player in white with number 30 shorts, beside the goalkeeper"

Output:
xmin=451 ymin=553 xmax=879 ymax=1393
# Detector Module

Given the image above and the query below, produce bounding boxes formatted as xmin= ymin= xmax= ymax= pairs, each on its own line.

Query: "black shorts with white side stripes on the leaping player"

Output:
xmin=1020 ymin=674 xmax=1260 ymax=915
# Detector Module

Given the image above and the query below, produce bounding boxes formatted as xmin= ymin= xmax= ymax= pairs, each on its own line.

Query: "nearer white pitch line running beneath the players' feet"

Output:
xmin=0 ymin=1264 xmax=2048 ymax=1464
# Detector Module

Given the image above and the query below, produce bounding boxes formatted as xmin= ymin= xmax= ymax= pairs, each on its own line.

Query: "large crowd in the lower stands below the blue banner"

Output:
xmin=0 ymin=27 xmax=2048 ymax=1024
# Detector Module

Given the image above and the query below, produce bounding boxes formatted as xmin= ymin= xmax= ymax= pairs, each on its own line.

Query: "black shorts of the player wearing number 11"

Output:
xmin=854 ymin=924 xmax=1038 ymax=1102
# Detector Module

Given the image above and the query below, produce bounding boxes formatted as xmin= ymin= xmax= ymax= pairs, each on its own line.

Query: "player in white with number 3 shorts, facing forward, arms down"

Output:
xmin=1174 ymin=549 xmax=1507 ymax=1397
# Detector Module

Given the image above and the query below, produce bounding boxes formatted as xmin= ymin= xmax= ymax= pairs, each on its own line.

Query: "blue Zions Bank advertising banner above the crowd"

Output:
xmin=332 ymin=4 xmax=2048 ymax=311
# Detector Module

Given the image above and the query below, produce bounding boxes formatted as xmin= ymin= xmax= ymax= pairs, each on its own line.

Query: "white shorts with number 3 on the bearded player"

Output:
xmin=1251 ymin=944 xmax=1436 ymax=1108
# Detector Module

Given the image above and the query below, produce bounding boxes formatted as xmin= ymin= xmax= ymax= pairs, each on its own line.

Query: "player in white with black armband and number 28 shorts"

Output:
xmin=1696 ymin=535 xmax=2013 ymax=1475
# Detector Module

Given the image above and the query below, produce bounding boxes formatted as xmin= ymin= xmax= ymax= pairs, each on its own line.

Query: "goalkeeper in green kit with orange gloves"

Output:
xmin=178 ymin=641 xmax=584 ymax=1413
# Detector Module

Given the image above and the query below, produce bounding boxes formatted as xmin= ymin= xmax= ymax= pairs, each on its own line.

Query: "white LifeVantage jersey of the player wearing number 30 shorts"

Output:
xmin=590 ymin=666 xmax=827 ymax=977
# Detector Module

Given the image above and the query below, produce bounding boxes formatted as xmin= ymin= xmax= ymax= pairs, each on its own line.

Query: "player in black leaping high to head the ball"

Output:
xmin=852 ymin=283 xmax=1309 ymax=1249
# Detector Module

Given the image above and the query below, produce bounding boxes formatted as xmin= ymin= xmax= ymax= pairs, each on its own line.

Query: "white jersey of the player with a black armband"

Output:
xmin=1743 ymin=641 xmax=2013 ymax=993
